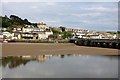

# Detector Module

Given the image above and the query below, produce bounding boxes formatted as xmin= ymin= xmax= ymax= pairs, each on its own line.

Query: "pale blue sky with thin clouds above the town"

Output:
xmin=2 ymin=0 xmax=118 ymax=31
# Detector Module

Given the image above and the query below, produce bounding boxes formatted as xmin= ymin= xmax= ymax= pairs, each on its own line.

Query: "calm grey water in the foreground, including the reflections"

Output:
xmin=0 ymin=54 xmax=118 ymax=78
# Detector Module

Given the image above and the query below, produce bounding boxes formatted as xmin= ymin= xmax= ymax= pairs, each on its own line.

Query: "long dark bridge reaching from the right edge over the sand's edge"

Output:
xmin=70 ymin=39 xmax=120 ymax=49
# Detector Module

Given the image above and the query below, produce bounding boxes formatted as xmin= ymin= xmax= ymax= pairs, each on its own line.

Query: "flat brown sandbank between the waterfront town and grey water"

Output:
xmin=2 ymin=43 xmax=118 ymax=56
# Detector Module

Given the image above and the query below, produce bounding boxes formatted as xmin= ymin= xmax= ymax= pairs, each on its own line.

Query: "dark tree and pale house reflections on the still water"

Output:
xmin=0 ymin=54 xmax=71 ymax=69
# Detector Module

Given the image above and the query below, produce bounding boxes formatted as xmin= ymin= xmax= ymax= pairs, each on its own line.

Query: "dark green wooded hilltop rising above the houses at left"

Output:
xmin=0 ymin=15 xmax=35 ymax=30
